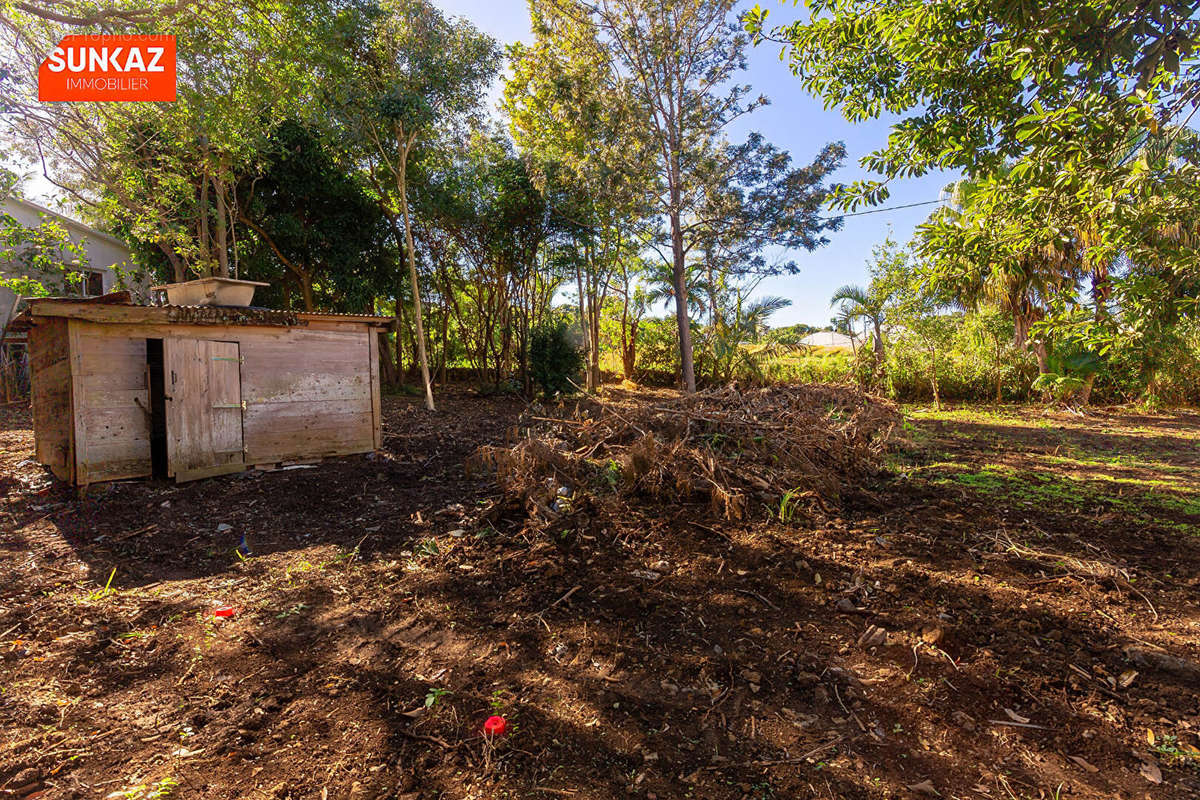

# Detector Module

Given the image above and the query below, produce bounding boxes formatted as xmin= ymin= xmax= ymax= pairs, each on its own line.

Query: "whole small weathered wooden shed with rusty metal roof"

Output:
xmin=22 ymin=295 xmax=392 ymax=486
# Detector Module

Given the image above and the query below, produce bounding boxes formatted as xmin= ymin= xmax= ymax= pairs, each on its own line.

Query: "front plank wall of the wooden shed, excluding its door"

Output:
xmin=62 ymin=320 xmax=379 ymax=483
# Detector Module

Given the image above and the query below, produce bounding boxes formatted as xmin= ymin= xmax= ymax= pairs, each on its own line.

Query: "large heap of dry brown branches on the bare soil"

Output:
xmin=473 ymin=385 xmax=900 ymax=527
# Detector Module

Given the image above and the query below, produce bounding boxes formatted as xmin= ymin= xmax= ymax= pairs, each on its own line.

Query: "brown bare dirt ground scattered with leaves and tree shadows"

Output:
xmin=0 ymin=391 xmax=1200 ymax=800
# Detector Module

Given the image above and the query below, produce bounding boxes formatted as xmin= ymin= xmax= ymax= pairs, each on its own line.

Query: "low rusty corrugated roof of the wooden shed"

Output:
xmin=11 ymin=291 xmax=395 ymax=330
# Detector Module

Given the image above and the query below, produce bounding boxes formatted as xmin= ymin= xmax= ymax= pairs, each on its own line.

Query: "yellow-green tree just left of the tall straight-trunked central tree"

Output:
xmin=503 ymin=0 xmax=654 ymax=391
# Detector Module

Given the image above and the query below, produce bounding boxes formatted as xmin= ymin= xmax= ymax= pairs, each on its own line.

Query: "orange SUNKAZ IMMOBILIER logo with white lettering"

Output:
xmin=37 ymin=36 xmax=175 ymax=102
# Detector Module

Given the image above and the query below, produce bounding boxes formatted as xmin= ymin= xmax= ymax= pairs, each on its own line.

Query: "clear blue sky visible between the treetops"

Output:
xmin=433 ymin=0 xmax=953 ymax=326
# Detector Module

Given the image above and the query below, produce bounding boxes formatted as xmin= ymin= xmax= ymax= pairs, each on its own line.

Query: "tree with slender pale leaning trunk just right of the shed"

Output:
xmin=346 ymin=0 xmax=499 ymax=411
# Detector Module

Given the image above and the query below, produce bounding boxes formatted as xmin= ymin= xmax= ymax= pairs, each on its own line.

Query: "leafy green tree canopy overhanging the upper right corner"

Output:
xmin=748 ymin=0 xmax=1200 ymax=367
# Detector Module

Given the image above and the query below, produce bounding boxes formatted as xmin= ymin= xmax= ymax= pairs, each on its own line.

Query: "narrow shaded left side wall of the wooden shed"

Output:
xmin=29 ymin=318 xmax=74 ymax=481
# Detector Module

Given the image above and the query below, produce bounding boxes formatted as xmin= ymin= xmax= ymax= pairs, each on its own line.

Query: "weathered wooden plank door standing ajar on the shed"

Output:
xmin=163 ymin=338 xmax=245 ymax=481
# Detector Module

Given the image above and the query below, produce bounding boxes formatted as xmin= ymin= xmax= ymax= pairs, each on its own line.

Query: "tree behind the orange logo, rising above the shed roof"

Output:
xmin=0 ymin=0 xmax=348 ymax=281
